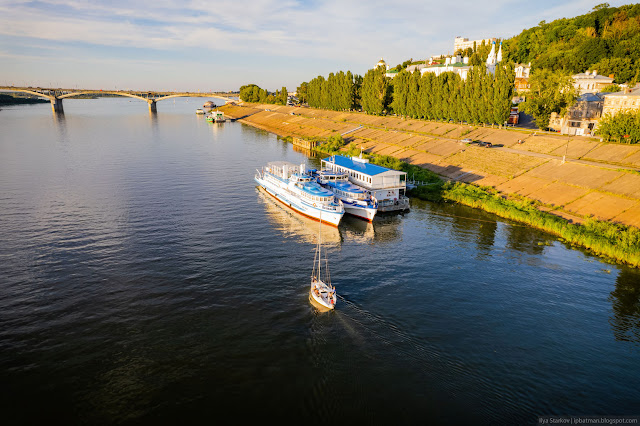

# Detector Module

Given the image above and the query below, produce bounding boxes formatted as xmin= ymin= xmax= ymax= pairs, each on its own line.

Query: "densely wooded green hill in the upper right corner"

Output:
xmin=502 ymin=3 xmax=640 ymax=83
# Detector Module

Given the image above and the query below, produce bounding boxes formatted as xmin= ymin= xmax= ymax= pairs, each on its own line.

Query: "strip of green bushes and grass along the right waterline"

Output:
xmin=442 ymin=183 xmax=640 ymax=267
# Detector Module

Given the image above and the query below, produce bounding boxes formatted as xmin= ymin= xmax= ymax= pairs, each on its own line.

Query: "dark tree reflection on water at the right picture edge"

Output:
xmin=609 ymin=267 xmax=640 ymax=343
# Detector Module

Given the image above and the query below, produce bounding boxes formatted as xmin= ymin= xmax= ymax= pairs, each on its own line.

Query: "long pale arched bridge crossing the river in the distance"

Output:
xmin=0 ymin=86 xmax=235 ymax=112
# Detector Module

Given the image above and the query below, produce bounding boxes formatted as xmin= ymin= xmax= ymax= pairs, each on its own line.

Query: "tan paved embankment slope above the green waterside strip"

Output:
xmin=220 ymin=104 xmax=640 ymax=227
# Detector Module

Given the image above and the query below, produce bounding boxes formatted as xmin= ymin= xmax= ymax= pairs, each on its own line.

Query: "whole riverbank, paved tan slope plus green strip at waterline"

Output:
xmin=220 ymin=104 xmax=640 ymax=267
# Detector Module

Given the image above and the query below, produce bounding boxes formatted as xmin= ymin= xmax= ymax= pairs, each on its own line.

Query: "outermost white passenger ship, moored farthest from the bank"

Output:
xmin=255 ymin=161 xmax=344 ymax=226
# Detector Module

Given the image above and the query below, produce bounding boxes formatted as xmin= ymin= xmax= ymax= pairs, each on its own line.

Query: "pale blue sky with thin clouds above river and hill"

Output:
xmin=0 ymin=0 xmax=628 ymax=91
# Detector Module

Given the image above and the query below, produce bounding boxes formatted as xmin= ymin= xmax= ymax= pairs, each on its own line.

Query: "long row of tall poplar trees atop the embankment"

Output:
xmin=296 ymin=63 xmax=515 ymax=124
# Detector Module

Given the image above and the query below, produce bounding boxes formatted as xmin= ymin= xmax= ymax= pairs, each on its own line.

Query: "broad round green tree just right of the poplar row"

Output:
xmin=520 ymin=69 xmax=577 ymax=129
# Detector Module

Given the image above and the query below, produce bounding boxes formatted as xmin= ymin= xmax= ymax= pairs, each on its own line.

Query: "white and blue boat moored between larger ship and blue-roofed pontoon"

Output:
xmin=313 ymin=170 xmax=378 ymax=222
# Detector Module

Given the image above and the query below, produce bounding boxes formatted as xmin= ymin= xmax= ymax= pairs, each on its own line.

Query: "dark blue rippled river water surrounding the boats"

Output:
xmin=0 ymin=99 xmax=640 ymax=424
